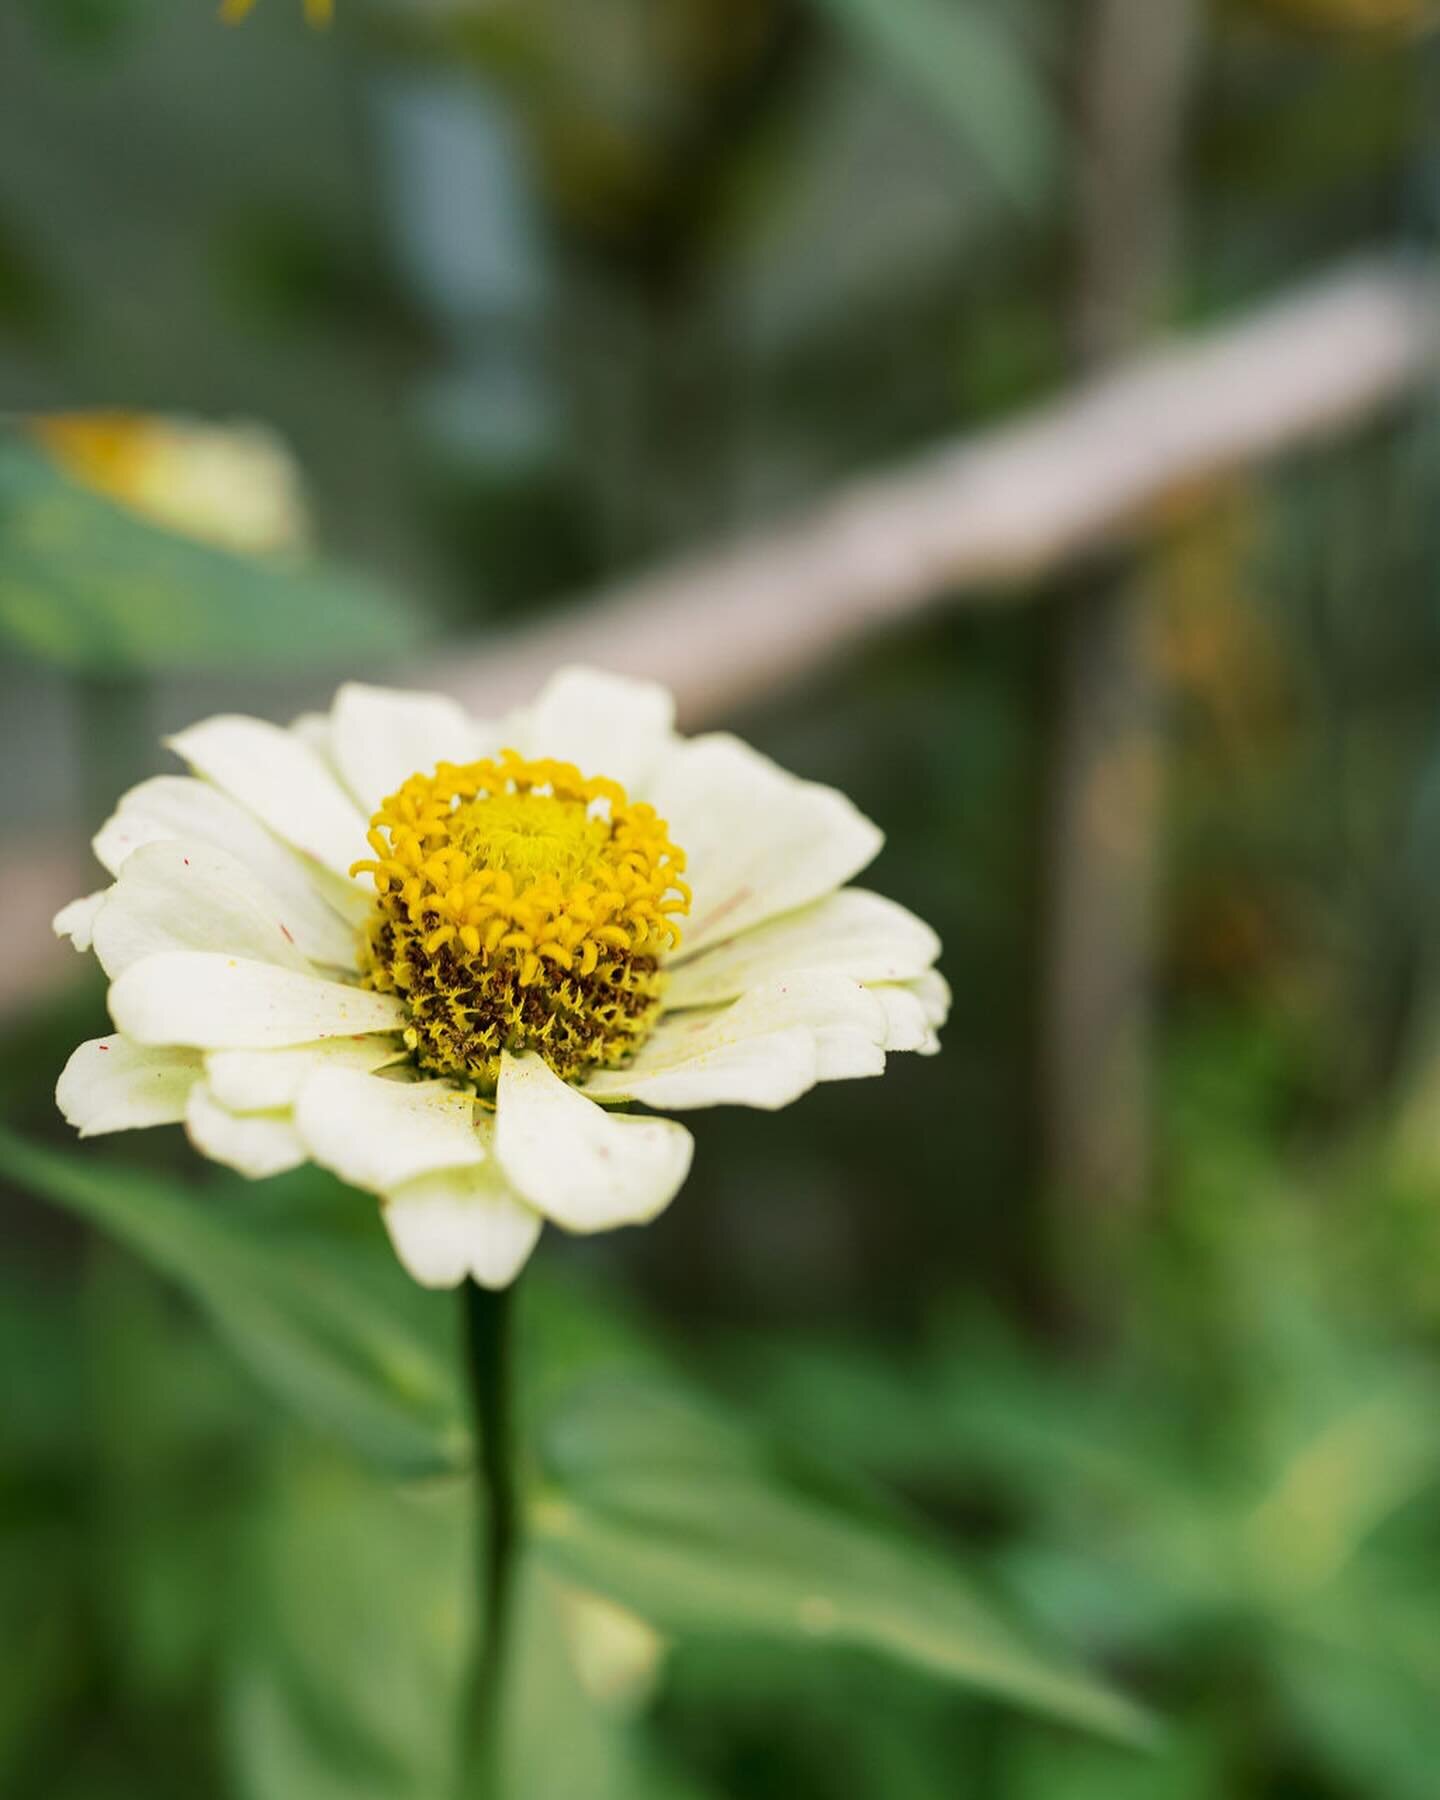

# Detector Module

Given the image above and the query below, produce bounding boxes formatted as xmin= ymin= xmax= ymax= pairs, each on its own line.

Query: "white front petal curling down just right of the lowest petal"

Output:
xmin=495 ymin=1055 xmax=695 ymax=1231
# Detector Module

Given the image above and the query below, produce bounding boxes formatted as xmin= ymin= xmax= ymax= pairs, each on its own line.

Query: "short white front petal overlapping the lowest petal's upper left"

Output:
xmin=295 ymin=1069 xmax=488 ymax=1193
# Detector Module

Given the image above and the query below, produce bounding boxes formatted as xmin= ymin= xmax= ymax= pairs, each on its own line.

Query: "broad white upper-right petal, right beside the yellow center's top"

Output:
xmin=648 ymin=733 xmax=884 ymax=956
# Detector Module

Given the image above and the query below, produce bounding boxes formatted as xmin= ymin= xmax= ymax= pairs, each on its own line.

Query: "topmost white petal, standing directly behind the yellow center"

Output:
xmin=518 ymin=668 xmax=675 ymax=794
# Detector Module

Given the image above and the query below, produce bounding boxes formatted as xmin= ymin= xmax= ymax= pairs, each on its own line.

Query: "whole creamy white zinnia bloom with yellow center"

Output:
xmin=56 ymin=670 xmax=949 ymax=1287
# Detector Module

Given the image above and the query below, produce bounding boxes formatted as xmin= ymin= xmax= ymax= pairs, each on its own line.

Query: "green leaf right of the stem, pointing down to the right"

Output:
xmin=535 ymin=1381 xmax=1148 ymax=1741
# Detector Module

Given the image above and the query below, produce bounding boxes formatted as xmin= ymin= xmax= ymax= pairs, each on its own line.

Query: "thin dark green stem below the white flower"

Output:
xmin=459 ymin=1282 xmax=520 ymax=1800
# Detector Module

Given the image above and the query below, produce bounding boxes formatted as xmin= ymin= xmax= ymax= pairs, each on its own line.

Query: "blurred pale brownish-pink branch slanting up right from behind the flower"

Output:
xmin=435 ymin=261 xmax=1440 ymax=724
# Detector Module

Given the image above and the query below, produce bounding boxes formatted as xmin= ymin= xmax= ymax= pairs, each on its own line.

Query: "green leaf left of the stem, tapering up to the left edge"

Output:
xmin=0 ymin=1130 xmax=466 ymax=1472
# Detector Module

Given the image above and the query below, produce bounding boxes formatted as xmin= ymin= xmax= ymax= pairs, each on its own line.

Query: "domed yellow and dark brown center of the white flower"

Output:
xmin=351 ymin=751 xmax=689 ymax=1093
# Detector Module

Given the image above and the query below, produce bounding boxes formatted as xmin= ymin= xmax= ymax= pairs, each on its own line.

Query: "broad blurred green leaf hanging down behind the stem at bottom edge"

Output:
xmin=227 ymin=1445 xmax=709 ymax=1800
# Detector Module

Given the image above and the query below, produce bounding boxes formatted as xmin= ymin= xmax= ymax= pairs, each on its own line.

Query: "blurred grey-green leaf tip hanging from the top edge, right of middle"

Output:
xmin=799 ymin=0 xmax=1060 ymax=214
